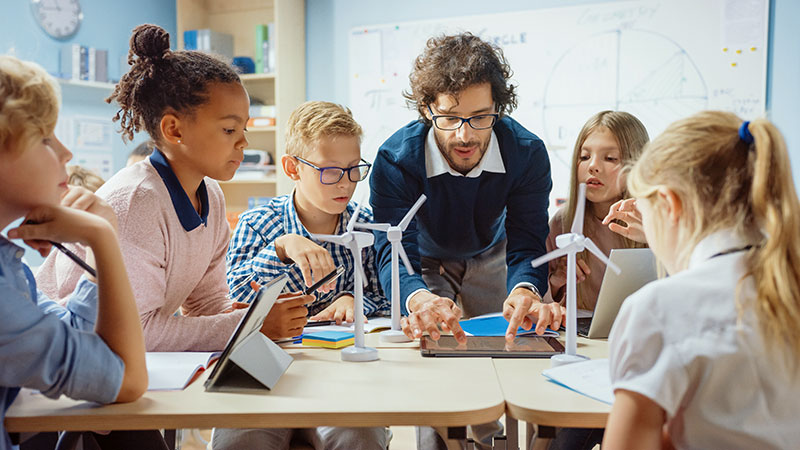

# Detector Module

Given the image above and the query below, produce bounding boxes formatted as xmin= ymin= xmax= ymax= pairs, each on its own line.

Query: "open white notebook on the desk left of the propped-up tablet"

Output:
xmin=145 ymin=352 xmax=222 ymax=391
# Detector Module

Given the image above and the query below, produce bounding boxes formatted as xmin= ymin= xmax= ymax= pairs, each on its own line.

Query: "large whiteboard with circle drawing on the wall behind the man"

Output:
xmin=348 ymin=0 xmax=769 ymax=214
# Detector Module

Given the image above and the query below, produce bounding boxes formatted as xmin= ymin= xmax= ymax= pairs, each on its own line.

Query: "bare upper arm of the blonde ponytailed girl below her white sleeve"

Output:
xmin=602 ymin=389 xmax=666 ymax=450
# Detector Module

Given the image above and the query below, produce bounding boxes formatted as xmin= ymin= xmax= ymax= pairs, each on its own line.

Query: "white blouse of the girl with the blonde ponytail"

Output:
xmin=609 ymin=231 xmax=800 ymax=450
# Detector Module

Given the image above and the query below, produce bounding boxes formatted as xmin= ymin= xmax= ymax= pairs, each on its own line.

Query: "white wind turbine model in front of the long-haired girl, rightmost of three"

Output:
xmin=531 ymin=183 xmax=621 ymax=367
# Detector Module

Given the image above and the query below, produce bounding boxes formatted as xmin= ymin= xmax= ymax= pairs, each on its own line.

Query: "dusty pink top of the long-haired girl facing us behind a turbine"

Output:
xmin=545 ymin=206 xmax=625 ymax=311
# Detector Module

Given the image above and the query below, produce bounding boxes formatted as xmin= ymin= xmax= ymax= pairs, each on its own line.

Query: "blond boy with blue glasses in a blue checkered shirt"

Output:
xmin=222 ymin=102 xmax=390 ymax=449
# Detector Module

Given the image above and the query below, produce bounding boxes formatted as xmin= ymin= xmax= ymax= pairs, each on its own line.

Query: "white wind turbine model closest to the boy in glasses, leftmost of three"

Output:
xmin=312 ymin=202 xmax=378 ymax=362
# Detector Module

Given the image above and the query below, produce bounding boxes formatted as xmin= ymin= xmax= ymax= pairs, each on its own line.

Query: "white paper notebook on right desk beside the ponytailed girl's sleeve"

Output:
xmin=542 ymin=359 xmax=614 ymax=405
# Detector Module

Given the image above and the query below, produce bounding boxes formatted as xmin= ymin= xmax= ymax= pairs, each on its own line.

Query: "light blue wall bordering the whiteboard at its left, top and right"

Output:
xmin=306 ymin=0 xmax=800 ymax=184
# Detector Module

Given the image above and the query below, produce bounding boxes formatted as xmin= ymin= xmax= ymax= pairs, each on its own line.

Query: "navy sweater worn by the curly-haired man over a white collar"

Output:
xmin=370 ymin=117 xmax=552 ymax=314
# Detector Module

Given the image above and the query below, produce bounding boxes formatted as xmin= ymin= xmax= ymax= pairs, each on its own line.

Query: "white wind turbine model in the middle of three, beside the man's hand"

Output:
xmin=356 ymin=194 xmax=427 ymax=342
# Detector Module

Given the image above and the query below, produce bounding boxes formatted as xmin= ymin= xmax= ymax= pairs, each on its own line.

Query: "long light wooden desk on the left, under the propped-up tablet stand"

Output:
xmin=5 ymin=348 xmax=505 ymax=432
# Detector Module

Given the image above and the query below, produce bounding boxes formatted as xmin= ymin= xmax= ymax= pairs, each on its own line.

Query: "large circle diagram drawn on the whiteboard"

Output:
xmin=540 ymin=30 xmax=708 ymax=153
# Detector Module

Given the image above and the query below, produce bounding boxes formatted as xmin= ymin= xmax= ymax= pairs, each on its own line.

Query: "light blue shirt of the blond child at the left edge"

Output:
xmin=0 ymin=236 xmax=125 ymax=450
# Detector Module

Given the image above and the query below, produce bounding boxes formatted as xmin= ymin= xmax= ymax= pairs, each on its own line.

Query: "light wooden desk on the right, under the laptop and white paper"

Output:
xmin=493 ymin=338 xmax=611 ymax=428
